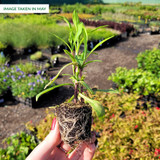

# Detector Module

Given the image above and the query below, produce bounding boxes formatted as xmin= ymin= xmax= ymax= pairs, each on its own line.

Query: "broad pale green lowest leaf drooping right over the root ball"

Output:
xmin=79 ymin=93 xmax=105 ymax=118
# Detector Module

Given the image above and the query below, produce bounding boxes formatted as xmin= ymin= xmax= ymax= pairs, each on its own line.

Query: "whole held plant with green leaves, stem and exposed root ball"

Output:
xmin=36 ymin=11 xmax=115 ymax=146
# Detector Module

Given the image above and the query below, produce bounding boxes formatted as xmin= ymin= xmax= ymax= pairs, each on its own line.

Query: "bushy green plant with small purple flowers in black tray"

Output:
xmin=11 ymin=74 xmax=53 ymax=107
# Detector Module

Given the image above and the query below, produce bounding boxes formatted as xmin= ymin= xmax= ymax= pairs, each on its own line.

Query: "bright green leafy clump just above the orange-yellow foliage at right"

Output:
xmin=108 ymin=67 xmax=160 ymax=95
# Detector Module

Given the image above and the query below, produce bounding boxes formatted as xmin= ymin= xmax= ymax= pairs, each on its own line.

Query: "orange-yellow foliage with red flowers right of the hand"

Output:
xmin=92 ymin=93 xmax=160 ymax=160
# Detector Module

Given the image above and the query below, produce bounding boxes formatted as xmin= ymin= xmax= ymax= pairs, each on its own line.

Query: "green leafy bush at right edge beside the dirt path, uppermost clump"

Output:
xmin=136 ymin=49 xmax=160 ymax=78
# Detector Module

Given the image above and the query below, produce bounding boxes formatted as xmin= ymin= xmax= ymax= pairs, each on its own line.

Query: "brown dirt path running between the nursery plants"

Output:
xmin=0 ymin=34 xmax=160 ymax=147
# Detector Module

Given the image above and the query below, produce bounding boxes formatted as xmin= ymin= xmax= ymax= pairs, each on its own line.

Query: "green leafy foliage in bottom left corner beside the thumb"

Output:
xmin=0 ymin=132 xmax=38 ymax=160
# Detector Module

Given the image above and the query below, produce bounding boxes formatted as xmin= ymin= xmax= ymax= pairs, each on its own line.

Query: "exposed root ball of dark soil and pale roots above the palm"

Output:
xmin=55 ymin=102 xmax=92 ymax=146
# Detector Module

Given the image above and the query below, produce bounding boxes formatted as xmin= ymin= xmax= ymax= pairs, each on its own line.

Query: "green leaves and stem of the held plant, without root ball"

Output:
xmin=36 ymin=11 xmax=115 ymax=117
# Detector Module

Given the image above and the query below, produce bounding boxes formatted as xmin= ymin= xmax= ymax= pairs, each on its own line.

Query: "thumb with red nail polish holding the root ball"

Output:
xmin=26 ymin=118 xmax=61 ymax=160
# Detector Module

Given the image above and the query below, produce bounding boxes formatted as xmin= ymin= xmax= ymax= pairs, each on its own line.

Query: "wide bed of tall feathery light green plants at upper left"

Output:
xmin=0 ymin=15 xmax=114 ymax=49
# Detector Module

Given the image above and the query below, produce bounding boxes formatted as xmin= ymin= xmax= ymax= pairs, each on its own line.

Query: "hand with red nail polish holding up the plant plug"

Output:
xmin=26 ymin=119 xmax=96 ymax=160
